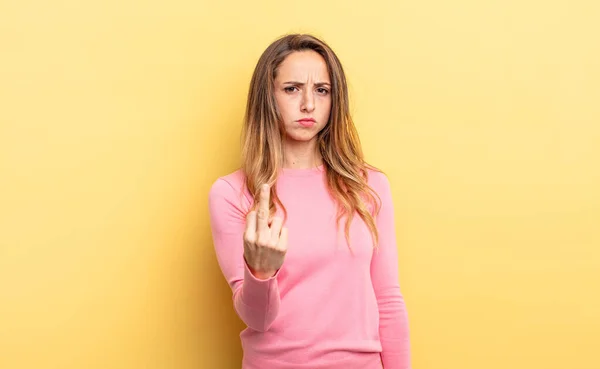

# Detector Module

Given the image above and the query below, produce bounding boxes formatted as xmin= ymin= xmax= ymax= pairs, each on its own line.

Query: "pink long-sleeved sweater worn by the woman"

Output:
xmin=209 ymin=166 xmax=410 ymax=369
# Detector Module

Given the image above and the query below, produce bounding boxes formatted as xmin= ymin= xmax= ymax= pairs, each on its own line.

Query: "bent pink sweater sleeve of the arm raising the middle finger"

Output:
xmin=208 ymin=178 xmax=280 ymax=332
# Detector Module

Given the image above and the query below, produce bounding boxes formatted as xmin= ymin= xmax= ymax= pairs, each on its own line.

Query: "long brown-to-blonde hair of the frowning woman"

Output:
xmin=241 ymin=34 xmax=381 ymax=247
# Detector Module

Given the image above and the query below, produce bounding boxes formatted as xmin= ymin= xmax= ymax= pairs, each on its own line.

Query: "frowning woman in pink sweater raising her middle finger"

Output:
xmin=209 ymin=34 xmax=410 ymax=369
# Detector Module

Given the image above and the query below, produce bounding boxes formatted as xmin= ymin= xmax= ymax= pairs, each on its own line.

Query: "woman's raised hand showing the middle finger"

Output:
xmin=244 ymin=184 xmax=287 ymax=279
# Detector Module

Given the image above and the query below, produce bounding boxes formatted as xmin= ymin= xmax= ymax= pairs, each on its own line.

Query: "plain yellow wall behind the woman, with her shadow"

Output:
xmin=0 ymin=0 xmax=600 ymax=369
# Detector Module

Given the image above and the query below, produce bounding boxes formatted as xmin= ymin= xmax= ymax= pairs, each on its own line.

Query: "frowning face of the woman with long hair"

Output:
xmin=275 ymin=50 xmax=331 ymax=141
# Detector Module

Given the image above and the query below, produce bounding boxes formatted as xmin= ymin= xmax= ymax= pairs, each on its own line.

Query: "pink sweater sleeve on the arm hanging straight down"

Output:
xmin=371 ymin=172 xmax=411 ymax=369
